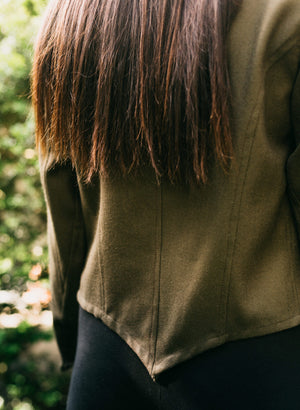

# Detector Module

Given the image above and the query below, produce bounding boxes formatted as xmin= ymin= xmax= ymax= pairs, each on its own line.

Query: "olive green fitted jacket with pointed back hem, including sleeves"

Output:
xmin=41 ymin=0 xmax=300 ymax=377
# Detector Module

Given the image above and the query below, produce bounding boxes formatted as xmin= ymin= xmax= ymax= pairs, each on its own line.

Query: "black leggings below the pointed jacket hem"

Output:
xmin=67 ymin=308 xmax=300 ymax=410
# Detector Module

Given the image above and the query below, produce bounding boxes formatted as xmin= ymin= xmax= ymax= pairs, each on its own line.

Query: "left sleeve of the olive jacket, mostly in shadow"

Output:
xmin=40 ymin=155 xmax=86 ymax=370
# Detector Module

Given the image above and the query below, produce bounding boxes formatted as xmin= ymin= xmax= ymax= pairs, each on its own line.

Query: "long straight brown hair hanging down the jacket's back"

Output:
xmin=32 ymin=0 xmax=241 ymax=183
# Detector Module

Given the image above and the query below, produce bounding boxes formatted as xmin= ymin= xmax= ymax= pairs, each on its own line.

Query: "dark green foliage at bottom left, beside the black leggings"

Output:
xmin=0 ymin=322 xmax=69 ymax=410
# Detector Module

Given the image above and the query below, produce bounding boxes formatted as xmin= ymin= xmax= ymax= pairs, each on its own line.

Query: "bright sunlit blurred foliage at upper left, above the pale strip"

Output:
xmin=0 ymin=0 xmax=47 ymax=290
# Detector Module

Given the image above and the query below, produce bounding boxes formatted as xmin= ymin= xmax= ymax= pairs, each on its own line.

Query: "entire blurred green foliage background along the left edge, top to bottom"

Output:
xmin=0 ymin=0 xmax=69 ymax=410
